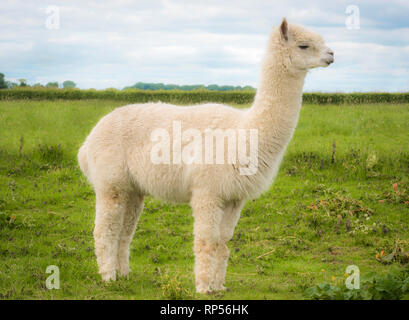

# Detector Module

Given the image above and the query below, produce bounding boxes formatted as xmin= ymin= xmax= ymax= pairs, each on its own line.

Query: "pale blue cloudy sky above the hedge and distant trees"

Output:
xmin=0 ymin=0 xmax=409 ymax=92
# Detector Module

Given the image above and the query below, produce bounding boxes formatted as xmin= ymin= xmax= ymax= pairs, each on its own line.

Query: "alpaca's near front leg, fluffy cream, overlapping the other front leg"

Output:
xmin=191 ymin=195 xmax=223 ymax=293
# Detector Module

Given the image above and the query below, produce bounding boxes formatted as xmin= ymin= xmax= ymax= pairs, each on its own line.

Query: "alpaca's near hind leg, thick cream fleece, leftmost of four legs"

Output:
xmin=94 ymin=190 xmax=127 ymax=281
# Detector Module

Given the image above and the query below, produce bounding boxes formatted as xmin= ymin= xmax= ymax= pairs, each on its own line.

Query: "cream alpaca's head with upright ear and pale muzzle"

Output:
xmin=269 ymin=19 xmax=334 ymax=73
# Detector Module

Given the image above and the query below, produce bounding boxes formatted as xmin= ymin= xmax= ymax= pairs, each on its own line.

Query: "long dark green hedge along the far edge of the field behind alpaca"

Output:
xmin=0 ymin=88 xmax=409 ymax=104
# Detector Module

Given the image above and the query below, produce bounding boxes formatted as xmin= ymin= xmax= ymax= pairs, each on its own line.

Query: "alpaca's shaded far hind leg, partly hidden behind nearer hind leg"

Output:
xmin=117 ymin=195 xmax=143 ymax=276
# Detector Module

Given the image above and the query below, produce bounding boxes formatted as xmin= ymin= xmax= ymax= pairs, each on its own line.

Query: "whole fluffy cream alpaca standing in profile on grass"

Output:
xmin=78 ymin=19 xmax=334 ymax=293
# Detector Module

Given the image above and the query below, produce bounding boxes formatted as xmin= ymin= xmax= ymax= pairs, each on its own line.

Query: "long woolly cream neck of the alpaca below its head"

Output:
xmin=247 ymin=59 xmax=306 ymax=160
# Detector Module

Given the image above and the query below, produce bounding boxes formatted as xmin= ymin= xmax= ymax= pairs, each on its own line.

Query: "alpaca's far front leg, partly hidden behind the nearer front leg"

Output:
xmin=212 ymin=201 xmax=244 ymax=290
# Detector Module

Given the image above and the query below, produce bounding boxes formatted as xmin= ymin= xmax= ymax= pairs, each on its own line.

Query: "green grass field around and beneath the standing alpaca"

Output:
xmin=0 ymin=100 xmax=409 ymax=299
